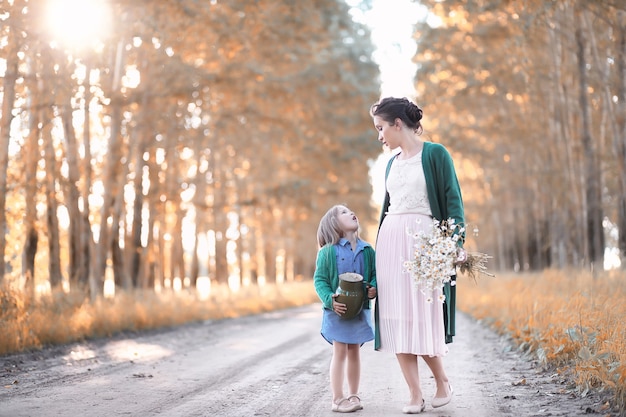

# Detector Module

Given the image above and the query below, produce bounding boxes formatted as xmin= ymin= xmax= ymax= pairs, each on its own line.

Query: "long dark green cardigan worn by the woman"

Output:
xmin=375 ymin=142 xmax=465 ymax=343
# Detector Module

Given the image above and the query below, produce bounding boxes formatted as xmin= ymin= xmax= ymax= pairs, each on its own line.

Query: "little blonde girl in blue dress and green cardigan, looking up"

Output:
xmin=313 ymin=205 xmax=376 ymax=413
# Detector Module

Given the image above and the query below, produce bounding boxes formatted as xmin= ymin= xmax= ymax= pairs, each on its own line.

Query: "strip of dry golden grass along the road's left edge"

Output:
xmin=0 ymin=281 xmax=319 ymax=356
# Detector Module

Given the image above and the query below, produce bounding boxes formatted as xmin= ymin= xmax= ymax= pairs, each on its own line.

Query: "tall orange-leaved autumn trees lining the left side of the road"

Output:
xmin=0 ymin=0 xmax=379 ymax=299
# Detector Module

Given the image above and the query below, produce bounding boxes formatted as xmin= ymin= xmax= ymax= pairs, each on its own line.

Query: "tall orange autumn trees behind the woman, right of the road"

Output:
xmin=415 ymin=1 xmax=624 ymax=269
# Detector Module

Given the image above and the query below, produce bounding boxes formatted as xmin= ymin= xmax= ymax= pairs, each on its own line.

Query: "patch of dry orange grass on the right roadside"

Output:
xmin=457 ymin=271 xmax=626 ymax=409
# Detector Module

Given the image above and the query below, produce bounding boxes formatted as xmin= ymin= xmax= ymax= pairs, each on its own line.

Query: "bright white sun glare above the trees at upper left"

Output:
xmin=47 ymin=0 xmax=112 ymax=49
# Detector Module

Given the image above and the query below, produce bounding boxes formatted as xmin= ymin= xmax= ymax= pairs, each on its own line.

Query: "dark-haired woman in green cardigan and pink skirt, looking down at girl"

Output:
xmin=370 ymin=97 xmax=465 ymax=414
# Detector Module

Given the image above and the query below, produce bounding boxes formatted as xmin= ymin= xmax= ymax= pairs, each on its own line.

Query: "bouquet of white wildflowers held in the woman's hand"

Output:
xmin=403 ymin=219 xmax=493 ymax=302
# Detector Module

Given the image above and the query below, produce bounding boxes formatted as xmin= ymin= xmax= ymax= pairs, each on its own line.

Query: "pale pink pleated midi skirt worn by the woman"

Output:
xmin=376 ymin=214 xmax=448 ymax=356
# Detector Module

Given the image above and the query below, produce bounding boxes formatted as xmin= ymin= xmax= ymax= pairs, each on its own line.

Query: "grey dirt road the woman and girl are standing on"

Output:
xmin=0 ymin=305 xmax=610 ymax=417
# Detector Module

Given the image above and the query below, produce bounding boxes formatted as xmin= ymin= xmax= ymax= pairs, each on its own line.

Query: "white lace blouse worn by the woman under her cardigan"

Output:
xmin=387 ymin=151 xmax=432 ymax=216
